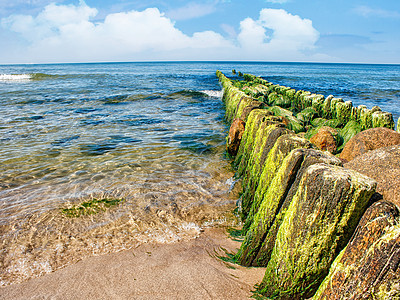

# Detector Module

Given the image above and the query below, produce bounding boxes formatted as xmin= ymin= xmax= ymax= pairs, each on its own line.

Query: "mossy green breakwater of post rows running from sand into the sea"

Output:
xmin=217 ymin=71 xmax=400 ymax=299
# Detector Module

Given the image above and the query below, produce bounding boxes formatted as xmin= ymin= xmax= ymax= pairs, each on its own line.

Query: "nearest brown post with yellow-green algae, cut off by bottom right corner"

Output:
xmin=313 ymin=201 xmax=400 ymax=300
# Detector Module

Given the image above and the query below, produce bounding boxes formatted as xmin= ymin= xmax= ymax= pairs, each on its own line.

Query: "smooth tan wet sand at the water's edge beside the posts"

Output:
xmin=0 ymin=228 xmax=265 ymax=299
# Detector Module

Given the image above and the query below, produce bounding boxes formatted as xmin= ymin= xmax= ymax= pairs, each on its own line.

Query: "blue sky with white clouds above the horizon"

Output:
xmin=0 ymin=0 xmax=400 ymax=64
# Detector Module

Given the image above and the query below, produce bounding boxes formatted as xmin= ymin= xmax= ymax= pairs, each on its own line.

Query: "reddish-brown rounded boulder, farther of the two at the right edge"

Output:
xmin=340 ymin=127 xmax=400 ymax=161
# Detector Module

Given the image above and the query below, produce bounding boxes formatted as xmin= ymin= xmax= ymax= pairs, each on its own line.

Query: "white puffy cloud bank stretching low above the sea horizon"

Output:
xmin=0 ymin=2 xmax=319 ymax=62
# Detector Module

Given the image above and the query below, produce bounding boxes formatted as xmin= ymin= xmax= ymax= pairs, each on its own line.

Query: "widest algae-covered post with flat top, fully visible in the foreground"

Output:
xmin=258 ymin=164 xmax=376 ymax=299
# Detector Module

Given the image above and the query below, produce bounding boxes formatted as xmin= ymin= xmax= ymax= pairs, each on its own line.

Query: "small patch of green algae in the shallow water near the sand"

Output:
xmin=61 ymin=198 xmax=124 ymax=218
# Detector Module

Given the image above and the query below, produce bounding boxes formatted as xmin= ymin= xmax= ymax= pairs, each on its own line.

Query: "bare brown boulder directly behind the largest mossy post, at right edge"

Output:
xmin=344 ymin=145 xmax=400 ymax=207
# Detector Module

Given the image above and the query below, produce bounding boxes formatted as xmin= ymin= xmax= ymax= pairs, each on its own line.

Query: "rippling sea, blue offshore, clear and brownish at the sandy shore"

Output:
xmin=0 ymin=62 xmax=400 ymax=286
